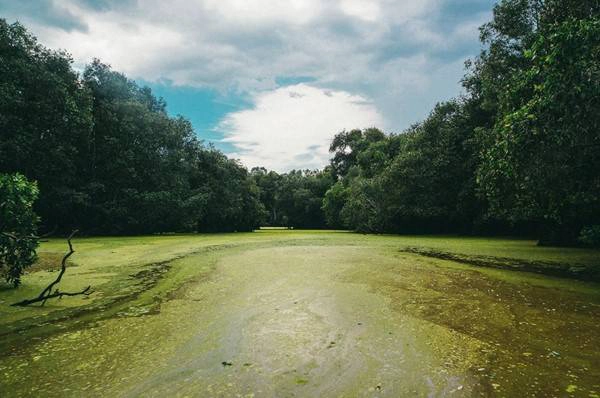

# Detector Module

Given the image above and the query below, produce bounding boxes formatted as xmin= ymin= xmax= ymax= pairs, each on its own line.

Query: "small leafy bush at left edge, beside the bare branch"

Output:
xmin=0 ymin=174 xmax=38 ymax=286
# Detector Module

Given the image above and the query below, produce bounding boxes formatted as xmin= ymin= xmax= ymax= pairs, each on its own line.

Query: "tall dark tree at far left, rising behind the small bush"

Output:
xmin=0 ymin=19 xmax=92 ymax=233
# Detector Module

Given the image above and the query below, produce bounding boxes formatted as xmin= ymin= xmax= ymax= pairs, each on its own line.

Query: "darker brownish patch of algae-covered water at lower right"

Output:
xmin=347 ymin=250 xmax=600 ymax=396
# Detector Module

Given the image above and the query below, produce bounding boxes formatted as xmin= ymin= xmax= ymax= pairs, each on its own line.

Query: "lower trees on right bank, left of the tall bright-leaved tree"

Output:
xmin=324 ymin=112 xmax=478 ymax=232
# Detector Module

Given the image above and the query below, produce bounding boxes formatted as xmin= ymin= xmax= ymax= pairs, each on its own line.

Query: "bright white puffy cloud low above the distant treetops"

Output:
xmin=219 ymin=84 xmax=383 ymax=171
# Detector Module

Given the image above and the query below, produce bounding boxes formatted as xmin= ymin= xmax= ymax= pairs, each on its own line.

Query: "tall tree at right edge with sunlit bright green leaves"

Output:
xmin=478 ymin=19 xmax=600 ymax=243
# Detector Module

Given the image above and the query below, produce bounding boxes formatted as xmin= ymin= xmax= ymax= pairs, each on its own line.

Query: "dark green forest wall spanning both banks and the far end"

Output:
xmin=0 ymin=0 xmax=600 ymax=245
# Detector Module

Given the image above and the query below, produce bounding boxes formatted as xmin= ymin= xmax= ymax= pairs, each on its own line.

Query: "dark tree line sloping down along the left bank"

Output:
xmin=0 ymin=20 xmax=264 ymax=234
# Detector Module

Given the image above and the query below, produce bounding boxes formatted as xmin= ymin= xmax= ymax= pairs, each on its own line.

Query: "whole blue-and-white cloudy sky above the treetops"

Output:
xmin=0 ymin=0 xmax=494 ymax=171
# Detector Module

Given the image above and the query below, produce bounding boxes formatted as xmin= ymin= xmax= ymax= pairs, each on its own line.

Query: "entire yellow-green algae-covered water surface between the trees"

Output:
xmin=0 ymin=230 xmax=600 ymax=397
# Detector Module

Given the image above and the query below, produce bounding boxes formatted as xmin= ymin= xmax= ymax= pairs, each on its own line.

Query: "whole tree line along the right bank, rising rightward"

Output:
xmin=324 ymin=0 xmax=600 ymax=244
